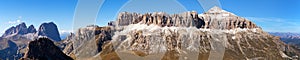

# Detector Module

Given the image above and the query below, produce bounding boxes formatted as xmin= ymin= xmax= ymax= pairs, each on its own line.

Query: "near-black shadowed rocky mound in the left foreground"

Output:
xmin=22 ymin=38 xmax=72 ymax=60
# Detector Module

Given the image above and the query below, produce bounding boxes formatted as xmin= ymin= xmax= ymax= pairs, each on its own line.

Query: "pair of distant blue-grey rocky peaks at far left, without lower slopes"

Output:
xmin=2 ymin=22 xmax=61 ymax=41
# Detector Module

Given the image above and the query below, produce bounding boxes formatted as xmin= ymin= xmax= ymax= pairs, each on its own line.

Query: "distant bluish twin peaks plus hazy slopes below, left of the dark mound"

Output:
xmin=0 ymin=22 xmax=61 ymax=60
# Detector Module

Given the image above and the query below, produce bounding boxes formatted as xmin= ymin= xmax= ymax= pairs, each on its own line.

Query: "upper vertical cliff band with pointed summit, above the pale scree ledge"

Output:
xmin=115 ymin=7 xmax=258 ymax=29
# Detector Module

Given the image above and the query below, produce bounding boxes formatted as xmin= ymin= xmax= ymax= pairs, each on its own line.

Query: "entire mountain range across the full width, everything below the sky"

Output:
xmin=0 ymin=7 xmax=300 ymax=60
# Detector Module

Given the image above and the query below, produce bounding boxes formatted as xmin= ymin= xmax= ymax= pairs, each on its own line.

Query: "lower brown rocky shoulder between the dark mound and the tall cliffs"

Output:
xmin=64 ymin=26 xmax=113 ymax=60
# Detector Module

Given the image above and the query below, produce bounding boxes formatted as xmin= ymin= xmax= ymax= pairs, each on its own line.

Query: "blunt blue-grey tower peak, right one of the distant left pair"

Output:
xmin=36 ymin=22 xmax=61 ymax=41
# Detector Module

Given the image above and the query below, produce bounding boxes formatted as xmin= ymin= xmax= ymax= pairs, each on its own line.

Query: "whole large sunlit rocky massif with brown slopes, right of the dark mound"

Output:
xmin=59 ymin=7 xmax=299 ymax=60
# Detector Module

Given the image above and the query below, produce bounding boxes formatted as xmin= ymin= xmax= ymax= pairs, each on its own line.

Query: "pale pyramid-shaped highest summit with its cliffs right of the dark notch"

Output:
xmin=199 ymin=7 xmax=259 ymax=29
